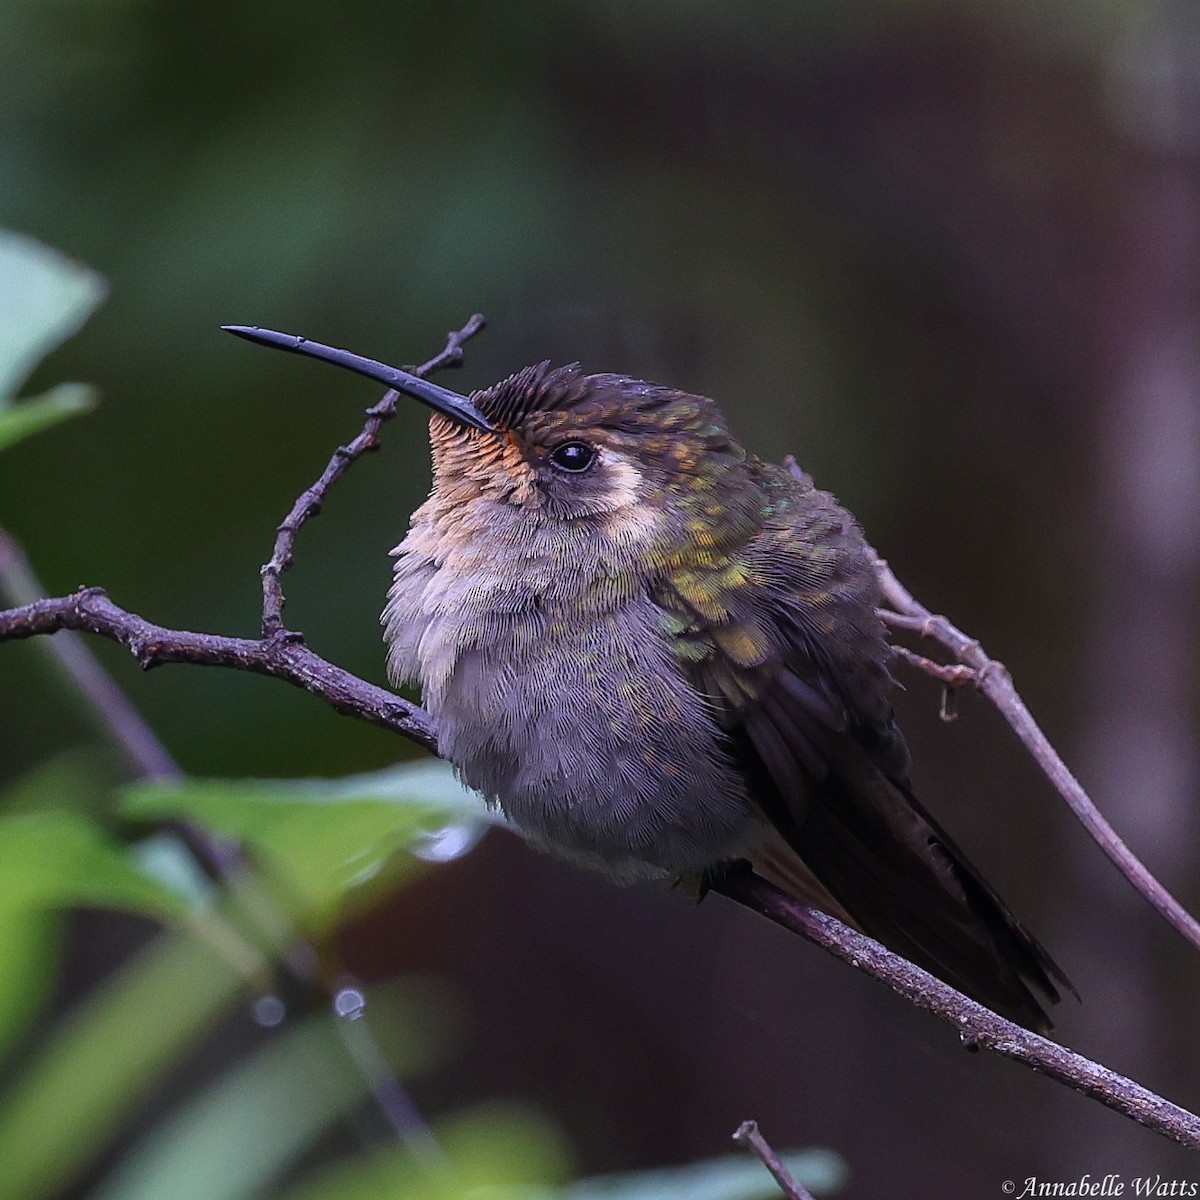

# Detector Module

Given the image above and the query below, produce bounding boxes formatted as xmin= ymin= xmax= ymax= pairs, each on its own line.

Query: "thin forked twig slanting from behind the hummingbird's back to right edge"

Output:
xmin=875 ymin=549 xmax=1200 ymax=949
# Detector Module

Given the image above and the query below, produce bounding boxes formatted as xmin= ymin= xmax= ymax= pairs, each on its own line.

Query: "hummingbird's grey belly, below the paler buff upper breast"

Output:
xmin=408 ymin=600 xmax=762 ymax=880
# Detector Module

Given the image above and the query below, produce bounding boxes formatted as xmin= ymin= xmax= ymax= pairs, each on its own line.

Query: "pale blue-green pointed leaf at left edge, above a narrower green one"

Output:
xmin=0 ymin=229 xmax=108 ymax=407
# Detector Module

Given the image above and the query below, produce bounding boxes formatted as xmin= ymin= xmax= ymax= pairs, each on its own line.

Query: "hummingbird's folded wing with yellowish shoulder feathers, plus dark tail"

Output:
xmin=655 ymin=463 xmax=1070 ymax=1028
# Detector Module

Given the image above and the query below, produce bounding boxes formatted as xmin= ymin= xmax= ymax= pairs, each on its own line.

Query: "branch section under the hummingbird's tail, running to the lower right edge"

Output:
xmin=713 ymin=870 xmax=1200 ymax=1150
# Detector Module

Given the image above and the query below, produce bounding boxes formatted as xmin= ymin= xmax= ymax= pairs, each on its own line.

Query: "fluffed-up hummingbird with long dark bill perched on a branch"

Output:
xmin=226 ymin=326 xmax=1073 ymax=1031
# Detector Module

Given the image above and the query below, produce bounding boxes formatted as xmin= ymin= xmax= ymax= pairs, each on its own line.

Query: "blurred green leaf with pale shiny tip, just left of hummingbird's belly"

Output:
xmin=122 ymin=767 xmax=482 ymax=928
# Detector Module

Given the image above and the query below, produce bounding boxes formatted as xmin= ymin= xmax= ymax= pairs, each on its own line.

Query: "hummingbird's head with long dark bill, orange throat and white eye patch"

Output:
xmin=227 ymin=326 xmax=756 ymax=566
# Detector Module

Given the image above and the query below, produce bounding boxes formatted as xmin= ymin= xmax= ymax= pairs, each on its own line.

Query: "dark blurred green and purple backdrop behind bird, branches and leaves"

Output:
xmin=0 ymin=0 xmax=1200 ymax=1198
